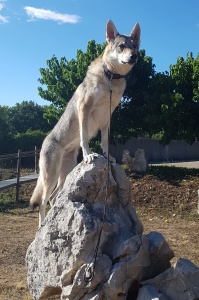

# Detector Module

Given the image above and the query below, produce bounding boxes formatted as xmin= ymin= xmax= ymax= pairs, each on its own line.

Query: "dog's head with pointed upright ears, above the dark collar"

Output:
xmin=105 ymin=20 xmax=141 ymax=74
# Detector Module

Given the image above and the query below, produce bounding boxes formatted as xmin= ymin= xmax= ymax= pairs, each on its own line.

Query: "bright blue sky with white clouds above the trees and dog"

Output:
xmin=0 ymin=0 xmax=199 ymax=106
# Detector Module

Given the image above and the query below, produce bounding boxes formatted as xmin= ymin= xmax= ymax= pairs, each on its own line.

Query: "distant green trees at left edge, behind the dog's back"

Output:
xmin=0 ymin=101 xmax=52 ymax=154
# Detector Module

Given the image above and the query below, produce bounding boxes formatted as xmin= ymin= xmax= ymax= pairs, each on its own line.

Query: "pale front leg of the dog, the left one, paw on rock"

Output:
xmin=78 ymin=101 xmax=94 ymax=163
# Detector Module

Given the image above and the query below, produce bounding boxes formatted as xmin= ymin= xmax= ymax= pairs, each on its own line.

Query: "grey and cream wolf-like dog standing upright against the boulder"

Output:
xmin=30 ymin=20 xmax=141 ymax=227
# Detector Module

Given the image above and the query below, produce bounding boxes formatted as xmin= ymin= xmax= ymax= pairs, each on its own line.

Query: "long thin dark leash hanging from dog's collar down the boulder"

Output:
xmin=84 ymin=70 xmax=113 ymax=284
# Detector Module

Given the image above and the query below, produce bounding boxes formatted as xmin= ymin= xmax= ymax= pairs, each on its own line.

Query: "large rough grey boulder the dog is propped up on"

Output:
xmin=26 ymin=156 xmax=173 ymax=300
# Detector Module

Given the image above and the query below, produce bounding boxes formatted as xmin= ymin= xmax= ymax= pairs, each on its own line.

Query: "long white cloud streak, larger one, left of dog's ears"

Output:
xmin=24 ymin=6 xmax=80 ymax=24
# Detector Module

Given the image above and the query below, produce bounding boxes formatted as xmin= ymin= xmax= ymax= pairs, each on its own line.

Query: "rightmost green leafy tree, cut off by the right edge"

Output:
xmin=162 ymin=52 xmax=199 ymax=144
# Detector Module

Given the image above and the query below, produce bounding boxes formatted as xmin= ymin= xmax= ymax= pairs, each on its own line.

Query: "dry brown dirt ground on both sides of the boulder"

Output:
xmin=0 ymin=167 xmax=199 ymax=300
